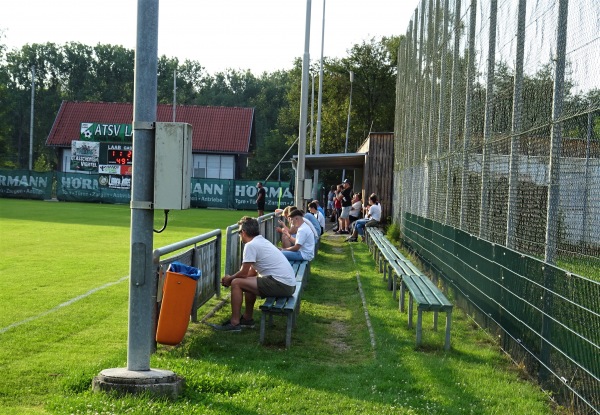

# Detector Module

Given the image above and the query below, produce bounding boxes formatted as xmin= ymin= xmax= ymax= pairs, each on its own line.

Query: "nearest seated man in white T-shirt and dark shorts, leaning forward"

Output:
xmin=211 ymin=216 xmax=296 ymax=332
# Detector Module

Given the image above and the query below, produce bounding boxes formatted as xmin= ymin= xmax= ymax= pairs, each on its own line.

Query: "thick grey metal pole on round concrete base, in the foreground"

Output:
xmin=92 ymin=0 xmax=183 ymax=398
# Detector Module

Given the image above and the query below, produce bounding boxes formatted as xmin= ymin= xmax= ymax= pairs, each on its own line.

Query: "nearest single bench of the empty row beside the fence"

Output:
xmin=400 ymin=275 xmax=452 ymax=350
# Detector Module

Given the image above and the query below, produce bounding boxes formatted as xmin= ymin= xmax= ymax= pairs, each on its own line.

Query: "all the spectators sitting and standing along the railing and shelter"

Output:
xmin=212 ymin=184 xmax=381 ymax=332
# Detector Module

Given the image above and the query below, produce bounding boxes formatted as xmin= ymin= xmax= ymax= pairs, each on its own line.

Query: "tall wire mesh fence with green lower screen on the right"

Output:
xmin=394 ymin=0 xmax=600 ymax=413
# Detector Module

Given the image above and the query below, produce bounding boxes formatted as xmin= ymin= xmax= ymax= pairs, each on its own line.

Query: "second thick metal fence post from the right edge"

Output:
xmin=506 ymin=0 xmax=527 ymax=249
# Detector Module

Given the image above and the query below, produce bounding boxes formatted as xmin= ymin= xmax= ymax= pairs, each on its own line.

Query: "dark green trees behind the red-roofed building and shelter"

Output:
xmin=0 ymin=37 xmax=399 ymax=180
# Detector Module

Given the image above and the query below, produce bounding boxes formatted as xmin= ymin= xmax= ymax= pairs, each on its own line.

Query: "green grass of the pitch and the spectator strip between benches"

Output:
xmin=0 ymin=199 xmax=556 ymax=415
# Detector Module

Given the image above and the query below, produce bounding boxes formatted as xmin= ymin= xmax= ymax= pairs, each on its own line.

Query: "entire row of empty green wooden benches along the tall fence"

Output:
xmin=366 ymin=228 xmax=453 ymax=350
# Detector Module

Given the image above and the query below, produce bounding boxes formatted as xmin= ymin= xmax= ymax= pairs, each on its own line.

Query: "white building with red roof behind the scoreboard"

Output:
xmin=46 ymin=101 xmax=255 ymax=179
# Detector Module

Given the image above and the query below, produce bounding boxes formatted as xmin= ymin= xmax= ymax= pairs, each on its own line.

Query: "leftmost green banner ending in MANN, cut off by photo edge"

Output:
xmin=0 ymin=170 xmax=54 ymax=200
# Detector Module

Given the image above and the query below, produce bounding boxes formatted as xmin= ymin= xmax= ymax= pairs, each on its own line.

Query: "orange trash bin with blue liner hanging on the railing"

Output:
xmin=156 ymin=263 xmax=199 ymax=346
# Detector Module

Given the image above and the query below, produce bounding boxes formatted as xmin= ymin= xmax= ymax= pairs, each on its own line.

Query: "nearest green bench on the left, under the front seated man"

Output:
xmin=259 ymin=261 xmax=310 ymax=348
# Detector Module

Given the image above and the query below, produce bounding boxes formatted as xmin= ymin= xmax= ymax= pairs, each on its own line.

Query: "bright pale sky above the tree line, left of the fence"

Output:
xmin=0 ymin=0 xmax=419 ymax=75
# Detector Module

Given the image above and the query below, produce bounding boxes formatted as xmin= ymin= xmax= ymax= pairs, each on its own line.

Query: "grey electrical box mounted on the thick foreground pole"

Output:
xmin=154 ymin=122 xmax=192 ymax=210
